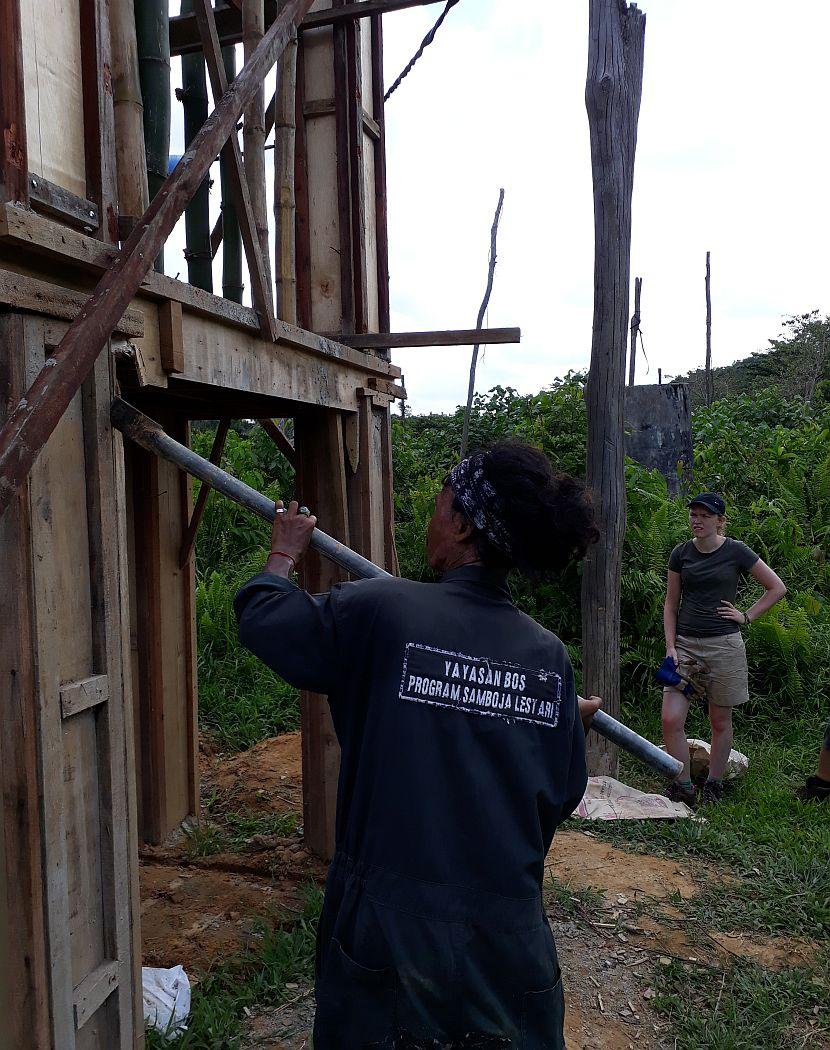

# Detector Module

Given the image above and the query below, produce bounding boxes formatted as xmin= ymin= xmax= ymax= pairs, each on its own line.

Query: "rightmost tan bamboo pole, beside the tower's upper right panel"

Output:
xmin=274 ymin=35 xmax=297 ymax=324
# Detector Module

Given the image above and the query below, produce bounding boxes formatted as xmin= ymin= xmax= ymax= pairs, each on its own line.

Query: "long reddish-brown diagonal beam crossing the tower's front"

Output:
xmin=0 ymin=0 xmax=313 ymax=515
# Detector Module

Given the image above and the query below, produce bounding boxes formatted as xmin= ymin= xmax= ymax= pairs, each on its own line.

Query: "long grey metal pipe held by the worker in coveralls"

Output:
xmin=110 ymin=398 xmax=683 ymax=778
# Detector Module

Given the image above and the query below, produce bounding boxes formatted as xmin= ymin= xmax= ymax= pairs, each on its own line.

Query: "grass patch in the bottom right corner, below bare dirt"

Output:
xmin=655 ymin=960 xmax=830 ymax=1050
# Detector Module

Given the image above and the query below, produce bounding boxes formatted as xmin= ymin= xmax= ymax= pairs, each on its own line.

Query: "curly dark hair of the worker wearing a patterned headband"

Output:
xmin=453 ymin=441 xmax=600 ymax=575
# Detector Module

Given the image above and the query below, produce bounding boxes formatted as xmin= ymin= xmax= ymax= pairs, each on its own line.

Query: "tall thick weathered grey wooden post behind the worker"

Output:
xmin=582 ymin=0 xmax=645 ymax=776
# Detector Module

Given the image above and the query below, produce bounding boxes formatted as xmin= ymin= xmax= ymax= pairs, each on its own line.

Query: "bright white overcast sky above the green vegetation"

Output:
xmin=167 ymin=0 xmax=830 ymax=412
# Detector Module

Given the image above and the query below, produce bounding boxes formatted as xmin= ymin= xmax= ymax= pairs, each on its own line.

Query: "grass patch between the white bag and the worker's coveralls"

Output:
xmin=147 ymin=885 xmax=323 ymax=1050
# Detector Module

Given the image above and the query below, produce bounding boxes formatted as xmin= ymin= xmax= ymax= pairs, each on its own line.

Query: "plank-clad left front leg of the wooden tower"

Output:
xmin=0 ymin=315 xmax=142 ymax=1050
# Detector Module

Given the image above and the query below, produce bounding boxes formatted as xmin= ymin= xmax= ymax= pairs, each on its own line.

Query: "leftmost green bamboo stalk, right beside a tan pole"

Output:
xmin=136 ymin=0 xmax=170 ymax=272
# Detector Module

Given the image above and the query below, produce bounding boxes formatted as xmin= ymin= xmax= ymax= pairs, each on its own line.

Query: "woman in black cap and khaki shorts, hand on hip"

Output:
xmin=663 ymin=492 xmax=787 ymax=803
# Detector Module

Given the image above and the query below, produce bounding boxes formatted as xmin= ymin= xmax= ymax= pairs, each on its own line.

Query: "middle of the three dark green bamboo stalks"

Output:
xmin=180 ymin=0 xmax=213 ymax=292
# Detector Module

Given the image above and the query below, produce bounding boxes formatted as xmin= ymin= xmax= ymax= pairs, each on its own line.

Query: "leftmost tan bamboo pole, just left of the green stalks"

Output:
xmin=109 ymin=0 xmax=150 ymax=223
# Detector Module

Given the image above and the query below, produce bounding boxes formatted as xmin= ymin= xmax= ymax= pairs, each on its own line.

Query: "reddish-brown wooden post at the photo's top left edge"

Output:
xmin=0 ymin=0 xmax=28 ymax=204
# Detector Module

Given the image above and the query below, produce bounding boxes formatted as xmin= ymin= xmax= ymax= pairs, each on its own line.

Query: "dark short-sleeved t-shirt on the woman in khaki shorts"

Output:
xmin=668 ymin=537 xmax=759 ymax=637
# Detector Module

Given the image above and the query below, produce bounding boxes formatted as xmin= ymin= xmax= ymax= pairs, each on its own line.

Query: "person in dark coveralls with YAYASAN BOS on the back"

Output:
xmin=235 ymin=442 xmax=601 ymax=1050
